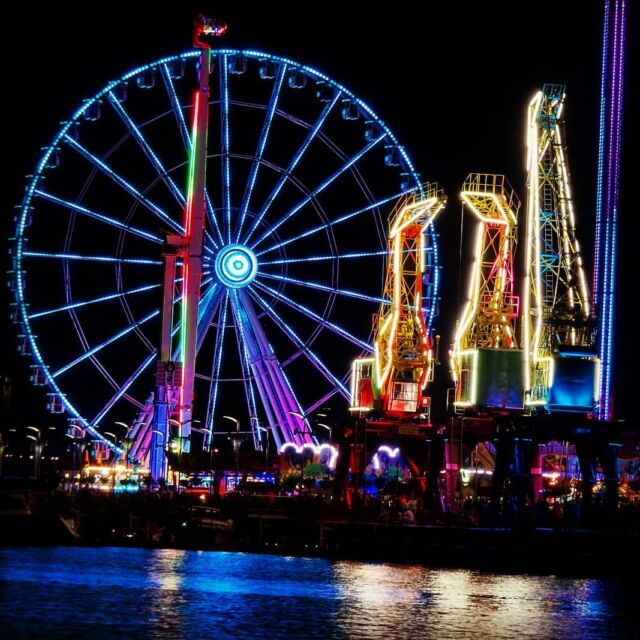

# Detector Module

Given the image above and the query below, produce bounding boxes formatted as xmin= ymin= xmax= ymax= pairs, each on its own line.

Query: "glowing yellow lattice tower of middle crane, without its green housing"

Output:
xmin=451 ymin=173 xmax=520 ymax=405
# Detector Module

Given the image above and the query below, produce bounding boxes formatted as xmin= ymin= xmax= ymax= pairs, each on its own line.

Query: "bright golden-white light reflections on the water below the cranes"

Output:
xmin=333 ymin=562 xmax=637 ymax=639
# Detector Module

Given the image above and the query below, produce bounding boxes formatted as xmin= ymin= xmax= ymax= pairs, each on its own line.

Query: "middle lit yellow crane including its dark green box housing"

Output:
xmin=451 ymin=173 xmax=522 ymax=410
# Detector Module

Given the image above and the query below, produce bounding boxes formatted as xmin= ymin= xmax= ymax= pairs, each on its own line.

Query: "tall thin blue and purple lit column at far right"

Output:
xmin=593 ymin=0 xmax=625 ymax=420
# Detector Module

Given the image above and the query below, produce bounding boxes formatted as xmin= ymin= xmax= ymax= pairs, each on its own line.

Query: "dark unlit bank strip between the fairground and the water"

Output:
xmin=0 ymin=492 xmax=640 ymax=577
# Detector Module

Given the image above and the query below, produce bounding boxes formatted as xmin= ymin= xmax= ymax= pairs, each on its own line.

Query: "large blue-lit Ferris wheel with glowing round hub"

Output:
xmin=13 ymin=49 xmax=438 ymax=458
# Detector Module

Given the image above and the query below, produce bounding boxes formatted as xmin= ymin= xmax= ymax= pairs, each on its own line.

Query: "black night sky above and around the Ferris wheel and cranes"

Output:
xmin=0 ymin=0 xmax=640 ymax=436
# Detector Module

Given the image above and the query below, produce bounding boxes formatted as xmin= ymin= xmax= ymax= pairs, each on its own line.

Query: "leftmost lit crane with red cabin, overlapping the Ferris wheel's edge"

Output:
xmin=336 ymin=184 xmax=446 ymax=492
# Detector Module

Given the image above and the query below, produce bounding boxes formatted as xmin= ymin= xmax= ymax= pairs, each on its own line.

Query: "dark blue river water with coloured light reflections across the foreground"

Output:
xmin=0 ymin=548 xmax=640 ymax=640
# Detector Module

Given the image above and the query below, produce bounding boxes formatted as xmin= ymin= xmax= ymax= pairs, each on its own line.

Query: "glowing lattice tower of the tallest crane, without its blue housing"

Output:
xmin=523 ymin=84 xmax=594 ymax=405
